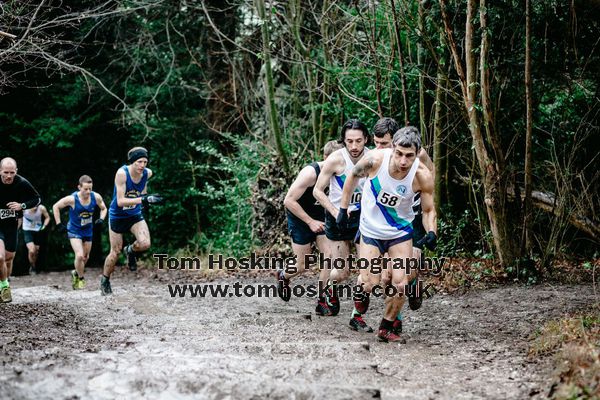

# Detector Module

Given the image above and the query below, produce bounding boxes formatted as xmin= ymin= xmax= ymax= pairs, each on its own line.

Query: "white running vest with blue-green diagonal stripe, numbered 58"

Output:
xmin=360 ymin=149 xmax=419 ymax=240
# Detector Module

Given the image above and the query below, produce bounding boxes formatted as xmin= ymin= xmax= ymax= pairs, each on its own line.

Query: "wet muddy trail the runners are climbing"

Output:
xmin=0 ymin=269 xmax=596 ymax=399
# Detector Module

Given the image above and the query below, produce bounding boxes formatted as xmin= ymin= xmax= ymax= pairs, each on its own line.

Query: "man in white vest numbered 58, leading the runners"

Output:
xmin=336 ymin=127 xmax=437 ymax=342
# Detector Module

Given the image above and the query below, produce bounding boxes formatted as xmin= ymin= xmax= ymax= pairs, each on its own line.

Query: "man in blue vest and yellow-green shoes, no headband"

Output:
xmin=52 ymin=175 xmax=107 ymax=290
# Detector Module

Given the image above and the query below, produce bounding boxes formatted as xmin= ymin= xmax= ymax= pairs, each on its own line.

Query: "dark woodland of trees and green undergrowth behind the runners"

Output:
xmin=0 ymin=0 xmax=600 ymax=281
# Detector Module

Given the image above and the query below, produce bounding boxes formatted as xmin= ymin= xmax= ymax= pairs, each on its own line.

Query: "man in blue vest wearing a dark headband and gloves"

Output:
xmin=100 ymin=147 xmax=163 ymax=296
